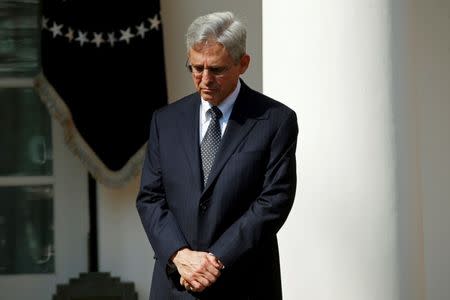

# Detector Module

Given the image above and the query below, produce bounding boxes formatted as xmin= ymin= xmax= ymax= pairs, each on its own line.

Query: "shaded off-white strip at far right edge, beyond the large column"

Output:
xmin=414 ymin=0 xmax=450 ymax=300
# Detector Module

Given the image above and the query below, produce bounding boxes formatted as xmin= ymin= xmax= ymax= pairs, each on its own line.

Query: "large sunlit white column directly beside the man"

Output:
xmin=263 ymin=0 xmax=424 ymax=300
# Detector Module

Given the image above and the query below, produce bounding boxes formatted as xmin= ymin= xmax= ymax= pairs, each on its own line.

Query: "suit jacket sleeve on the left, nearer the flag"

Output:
xmin=136 ymin=112 xmax=188 ymax=263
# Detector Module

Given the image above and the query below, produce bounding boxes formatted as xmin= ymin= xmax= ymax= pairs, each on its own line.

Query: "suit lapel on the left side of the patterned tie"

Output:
xmin=177 ymin=94 xmax=203 ymax=191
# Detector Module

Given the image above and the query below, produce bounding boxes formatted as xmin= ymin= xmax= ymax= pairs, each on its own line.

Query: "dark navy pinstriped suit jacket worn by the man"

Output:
xmin=137 ymin=81 xmax=298 ymax=300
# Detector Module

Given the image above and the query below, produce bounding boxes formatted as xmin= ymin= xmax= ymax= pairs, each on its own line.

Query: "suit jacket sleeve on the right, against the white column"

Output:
xmin=209 ymin=111 xmax=298 ymax=266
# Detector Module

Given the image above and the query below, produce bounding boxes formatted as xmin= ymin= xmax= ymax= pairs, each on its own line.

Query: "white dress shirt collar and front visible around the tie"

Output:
xmin=200 ymin=80 xmax=241 ymax=143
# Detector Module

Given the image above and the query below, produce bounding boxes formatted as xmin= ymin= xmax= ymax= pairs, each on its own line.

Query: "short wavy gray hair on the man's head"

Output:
xmin=186 ymin=11 xmax=247 ymax=63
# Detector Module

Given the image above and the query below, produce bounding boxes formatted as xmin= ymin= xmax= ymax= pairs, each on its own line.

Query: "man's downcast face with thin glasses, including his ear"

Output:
xmin=188 ymin=42 xmax=250 ymax=105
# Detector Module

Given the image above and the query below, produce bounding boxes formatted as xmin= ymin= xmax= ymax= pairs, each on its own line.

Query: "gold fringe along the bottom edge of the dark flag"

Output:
xmin=34 ymin=72 xmax=146 ymax=187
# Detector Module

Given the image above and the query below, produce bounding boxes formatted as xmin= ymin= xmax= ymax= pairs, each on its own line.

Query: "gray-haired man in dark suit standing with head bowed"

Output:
xmin=137 ymin=12 xmax=298 ymax=300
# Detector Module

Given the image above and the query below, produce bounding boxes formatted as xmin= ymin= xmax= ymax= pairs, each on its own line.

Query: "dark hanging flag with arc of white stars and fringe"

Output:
xmin=36 ymin=0 xmax=167 ymax=186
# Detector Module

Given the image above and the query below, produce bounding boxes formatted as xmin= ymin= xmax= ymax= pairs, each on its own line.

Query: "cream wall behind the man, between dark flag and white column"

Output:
xmin=98 ymin=0 xmax=262 ymax=300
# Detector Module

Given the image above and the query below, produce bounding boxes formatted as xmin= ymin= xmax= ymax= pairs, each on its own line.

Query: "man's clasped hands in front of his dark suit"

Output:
xmin=172 ymin=248 xmax=224 ymax=292
